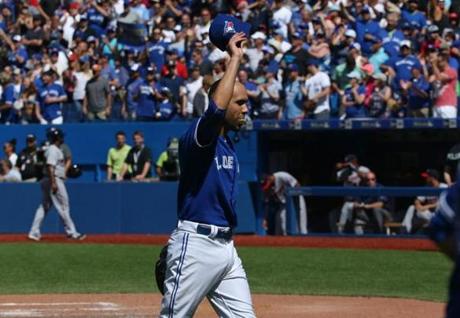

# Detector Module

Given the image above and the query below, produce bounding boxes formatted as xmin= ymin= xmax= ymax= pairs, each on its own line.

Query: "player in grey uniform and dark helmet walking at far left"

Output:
xmin=28 ymin=128 xmax=86 ymax=241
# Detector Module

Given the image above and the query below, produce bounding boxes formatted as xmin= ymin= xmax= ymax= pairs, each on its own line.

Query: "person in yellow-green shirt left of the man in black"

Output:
xmin=107 ymin=131 xmax=131 ymax=181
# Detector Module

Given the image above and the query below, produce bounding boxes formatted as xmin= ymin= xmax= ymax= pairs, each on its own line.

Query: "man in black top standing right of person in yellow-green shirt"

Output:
xmin=117 ymin=131 xmax=152 ymax=181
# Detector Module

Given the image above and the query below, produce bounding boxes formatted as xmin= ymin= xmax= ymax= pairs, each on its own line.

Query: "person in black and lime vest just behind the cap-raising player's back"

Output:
xmin=156 ymin=138 xmax=180 ymax=181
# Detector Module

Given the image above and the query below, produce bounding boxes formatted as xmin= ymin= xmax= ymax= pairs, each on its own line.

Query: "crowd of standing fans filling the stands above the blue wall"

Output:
xmin=0 ymin=0 xmax=460 ymax=124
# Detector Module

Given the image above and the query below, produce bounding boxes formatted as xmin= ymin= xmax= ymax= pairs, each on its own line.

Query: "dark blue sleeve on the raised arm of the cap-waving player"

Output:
xmin=194 ymin=98 xmax=225 ymax=148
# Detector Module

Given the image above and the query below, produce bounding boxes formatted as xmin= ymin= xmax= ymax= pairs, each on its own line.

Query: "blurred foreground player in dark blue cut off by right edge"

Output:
xmin=429 ymin=180 xmax=460 ymax=318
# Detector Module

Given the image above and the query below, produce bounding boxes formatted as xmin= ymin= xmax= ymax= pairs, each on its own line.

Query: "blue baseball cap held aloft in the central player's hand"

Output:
xmin=209 ymin=14 xmax=251 ymax=51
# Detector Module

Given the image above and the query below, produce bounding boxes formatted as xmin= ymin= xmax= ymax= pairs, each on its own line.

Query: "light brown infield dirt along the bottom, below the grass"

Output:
xmin=0 ymin=294 xmax=443 ymax=318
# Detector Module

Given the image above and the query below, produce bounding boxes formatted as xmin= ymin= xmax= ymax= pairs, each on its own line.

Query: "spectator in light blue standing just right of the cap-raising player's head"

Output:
xmin=282 ymin=64 xmax=305 ymax=120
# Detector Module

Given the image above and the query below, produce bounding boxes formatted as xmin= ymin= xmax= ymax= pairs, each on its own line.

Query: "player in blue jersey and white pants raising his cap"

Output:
xmin=156 ymin=15 xmax=255 ymax=318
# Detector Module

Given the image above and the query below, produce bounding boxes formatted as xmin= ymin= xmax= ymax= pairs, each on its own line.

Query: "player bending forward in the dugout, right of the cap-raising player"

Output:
xmin=263 ymin=171 xmax=308 ymax=235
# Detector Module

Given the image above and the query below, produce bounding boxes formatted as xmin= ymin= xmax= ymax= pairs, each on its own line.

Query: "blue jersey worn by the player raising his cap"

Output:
xmin=178 ymin=100 xmax=239 ymax=227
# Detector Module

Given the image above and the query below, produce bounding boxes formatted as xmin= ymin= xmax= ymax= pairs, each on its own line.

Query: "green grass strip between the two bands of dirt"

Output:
xmin=0 ymin=243 xmax=451 ymax=301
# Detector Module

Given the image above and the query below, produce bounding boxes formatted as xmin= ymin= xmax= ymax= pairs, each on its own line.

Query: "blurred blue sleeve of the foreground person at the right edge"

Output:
xmin=428 ymin=184 xmax=460 ymax=243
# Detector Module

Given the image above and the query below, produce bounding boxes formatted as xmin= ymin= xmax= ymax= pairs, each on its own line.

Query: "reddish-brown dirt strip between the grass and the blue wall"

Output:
xmin=0 ymin=234 xmax=436 ymax=251
